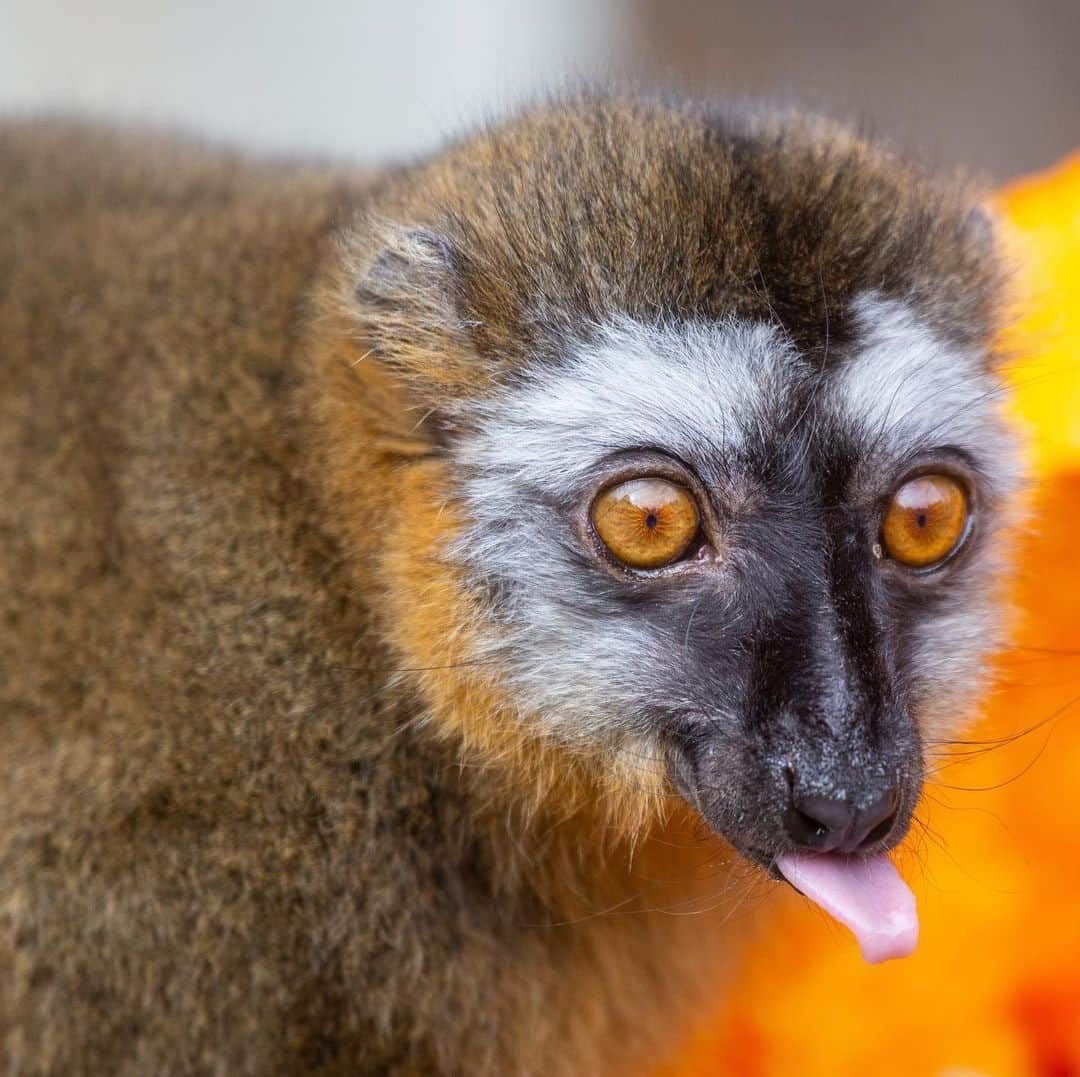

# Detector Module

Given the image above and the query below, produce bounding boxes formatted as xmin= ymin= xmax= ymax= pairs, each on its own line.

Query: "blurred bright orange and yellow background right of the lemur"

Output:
xmin=658 ymin=154 xmax=1080 ymax=1077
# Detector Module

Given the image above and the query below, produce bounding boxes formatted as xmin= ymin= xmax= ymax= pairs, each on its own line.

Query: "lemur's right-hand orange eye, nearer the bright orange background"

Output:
xmin=881 ymin=475 xmax=968 ymax=568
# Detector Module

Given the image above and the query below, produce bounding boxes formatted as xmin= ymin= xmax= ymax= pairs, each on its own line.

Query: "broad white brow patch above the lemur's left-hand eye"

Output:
xmin=459 ymin=319 xmax=806 ymax=496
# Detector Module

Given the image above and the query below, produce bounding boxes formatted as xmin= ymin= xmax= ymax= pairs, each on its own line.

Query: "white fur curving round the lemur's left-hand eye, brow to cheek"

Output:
xmin=454 ymin=321 xmax=805 ymax=741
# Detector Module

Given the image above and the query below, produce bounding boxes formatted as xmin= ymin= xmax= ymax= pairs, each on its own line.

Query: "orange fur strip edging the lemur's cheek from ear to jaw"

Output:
xmin=308 ymin=315 xmax=673 ymax=844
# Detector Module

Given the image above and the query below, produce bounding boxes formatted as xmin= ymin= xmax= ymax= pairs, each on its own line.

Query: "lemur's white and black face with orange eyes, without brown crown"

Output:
xmin=455 ymin=293 xmax=1012 ymax=865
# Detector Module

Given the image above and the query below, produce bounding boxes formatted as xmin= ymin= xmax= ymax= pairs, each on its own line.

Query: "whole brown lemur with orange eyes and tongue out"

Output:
xmin=0 ymin=92 xmax=1018 ymax=1077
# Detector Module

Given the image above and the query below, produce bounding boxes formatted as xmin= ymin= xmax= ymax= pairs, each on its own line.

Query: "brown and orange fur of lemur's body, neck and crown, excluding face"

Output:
xmin=0 ymin=96 xmax=989 ymax=1074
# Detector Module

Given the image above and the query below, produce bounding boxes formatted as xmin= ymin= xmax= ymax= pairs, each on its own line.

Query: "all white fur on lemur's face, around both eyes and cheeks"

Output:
xmin=450 ymin=294 xmax=1017 ymax=741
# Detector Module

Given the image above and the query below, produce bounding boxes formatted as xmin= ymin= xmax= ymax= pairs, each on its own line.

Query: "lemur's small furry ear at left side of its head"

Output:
xmin=353 ymin=227 xmax=485 ymax=410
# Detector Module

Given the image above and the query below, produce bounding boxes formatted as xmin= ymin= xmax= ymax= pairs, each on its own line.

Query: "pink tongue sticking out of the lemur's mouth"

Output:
xmin=777 ymin=852 xmax=919 ymax=965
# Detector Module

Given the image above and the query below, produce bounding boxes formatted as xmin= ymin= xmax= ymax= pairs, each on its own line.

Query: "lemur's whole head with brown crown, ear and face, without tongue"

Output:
xmin=332 ymin=99 xmax=1014 ymax=954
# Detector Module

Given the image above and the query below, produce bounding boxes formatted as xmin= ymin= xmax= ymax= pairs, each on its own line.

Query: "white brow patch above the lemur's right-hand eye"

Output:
xmin=829 ymin=293 xmax=1015 ymax=473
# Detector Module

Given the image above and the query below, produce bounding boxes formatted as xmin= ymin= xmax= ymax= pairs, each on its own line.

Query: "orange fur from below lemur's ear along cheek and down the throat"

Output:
xmin=302 ymin=317 xmax=760 ymax=1073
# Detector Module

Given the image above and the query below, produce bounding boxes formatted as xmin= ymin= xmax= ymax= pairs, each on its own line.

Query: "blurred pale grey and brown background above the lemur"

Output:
xmin=0 ymin=0 xmax=1080 ymax=180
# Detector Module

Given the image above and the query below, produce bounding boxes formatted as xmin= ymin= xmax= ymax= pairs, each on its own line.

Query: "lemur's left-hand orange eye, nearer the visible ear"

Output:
xmin=593 ymin=479 xmax=698 ymax=568
